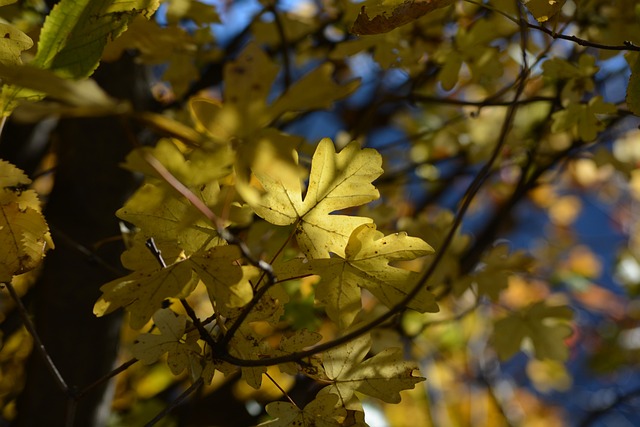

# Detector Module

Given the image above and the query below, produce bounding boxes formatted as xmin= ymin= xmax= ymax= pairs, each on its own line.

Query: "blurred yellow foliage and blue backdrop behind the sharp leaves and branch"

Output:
xmin=0 ymin=0 xmax=640 ymax=427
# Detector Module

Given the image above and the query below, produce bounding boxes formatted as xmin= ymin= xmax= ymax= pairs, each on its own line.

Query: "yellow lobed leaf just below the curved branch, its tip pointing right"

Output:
xmin=320 ymin=334 xmax=426 ymax=403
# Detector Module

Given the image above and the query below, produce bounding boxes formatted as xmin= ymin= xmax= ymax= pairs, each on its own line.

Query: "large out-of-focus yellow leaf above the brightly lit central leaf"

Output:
xmin=189 ymin=43 xmax=359 ymax=203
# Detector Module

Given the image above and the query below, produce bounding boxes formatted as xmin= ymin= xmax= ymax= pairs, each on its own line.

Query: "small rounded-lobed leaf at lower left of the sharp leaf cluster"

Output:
xmin=131 ymin=308 xmax=201 ymax=375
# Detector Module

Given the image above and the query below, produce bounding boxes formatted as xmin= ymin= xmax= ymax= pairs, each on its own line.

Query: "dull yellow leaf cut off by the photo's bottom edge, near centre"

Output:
xmin=259 ymin=394 xmax=347 ymax=427
